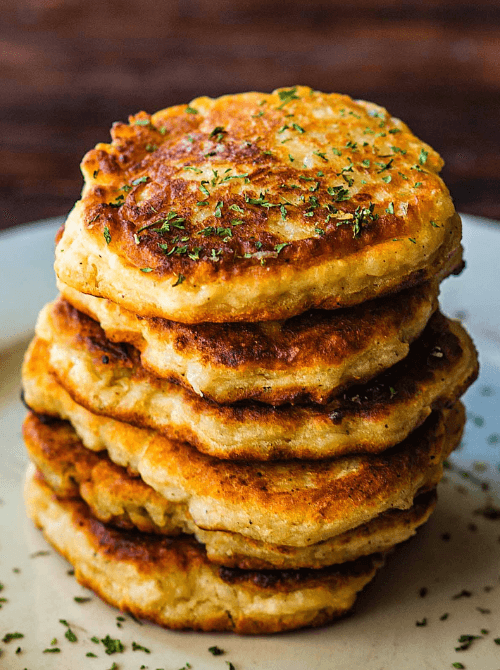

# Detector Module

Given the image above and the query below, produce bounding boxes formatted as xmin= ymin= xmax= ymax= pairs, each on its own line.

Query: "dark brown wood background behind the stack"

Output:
xmin=0 ymin=0 xmax=500 ymax=228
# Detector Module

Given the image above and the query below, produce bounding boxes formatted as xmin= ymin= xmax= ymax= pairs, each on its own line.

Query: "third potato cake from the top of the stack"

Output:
xmin=29 ymin=305 xmax=477 ymax=460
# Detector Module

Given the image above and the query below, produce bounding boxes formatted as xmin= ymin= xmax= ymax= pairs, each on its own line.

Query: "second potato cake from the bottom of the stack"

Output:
xmin=23 ymin=412 xmax=436 ymax=570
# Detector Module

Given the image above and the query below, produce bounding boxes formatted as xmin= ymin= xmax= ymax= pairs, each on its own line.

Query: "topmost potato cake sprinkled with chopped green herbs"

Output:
xmin=55 ymin=86 xmax=462 ymax=323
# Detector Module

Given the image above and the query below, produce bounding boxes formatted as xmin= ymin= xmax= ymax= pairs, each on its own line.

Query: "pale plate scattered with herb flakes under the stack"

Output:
xmin=0 ymin=217 xmax=500 ymax=670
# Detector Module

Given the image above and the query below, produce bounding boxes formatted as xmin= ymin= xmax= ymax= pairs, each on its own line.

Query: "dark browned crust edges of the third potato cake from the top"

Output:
xmin=38 ymin=301 xmax=479 ymax=460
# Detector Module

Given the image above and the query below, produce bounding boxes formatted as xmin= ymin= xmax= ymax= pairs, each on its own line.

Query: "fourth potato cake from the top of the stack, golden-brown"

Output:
xmin=19 ymin=376 xmax=465 ymax=547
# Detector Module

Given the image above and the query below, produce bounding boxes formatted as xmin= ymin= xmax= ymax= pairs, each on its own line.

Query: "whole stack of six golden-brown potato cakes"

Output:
xmin=23 ymin=87 xmax=478 ymax=633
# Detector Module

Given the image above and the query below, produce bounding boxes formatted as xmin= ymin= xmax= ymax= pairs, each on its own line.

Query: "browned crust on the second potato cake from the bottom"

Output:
xmin=23 ymin=412 xmax=437 ymax=570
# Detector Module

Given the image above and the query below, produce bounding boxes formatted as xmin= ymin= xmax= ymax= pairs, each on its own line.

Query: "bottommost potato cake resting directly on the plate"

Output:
xmin=25 ymin=466 xmax=383 ymax=633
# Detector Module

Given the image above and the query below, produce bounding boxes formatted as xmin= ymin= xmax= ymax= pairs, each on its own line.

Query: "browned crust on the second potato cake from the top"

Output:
xmin=57 ymin=284 xmax=438 ymax=405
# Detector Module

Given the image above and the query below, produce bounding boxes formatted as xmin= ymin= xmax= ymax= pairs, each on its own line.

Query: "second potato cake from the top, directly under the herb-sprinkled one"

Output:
xmin=56 ymin=283 xmax=438 ymax=405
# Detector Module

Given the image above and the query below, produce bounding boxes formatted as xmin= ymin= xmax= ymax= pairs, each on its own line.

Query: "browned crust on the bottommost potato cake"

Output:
xmin=26 ymin=474 xmax=383 ymax=634
